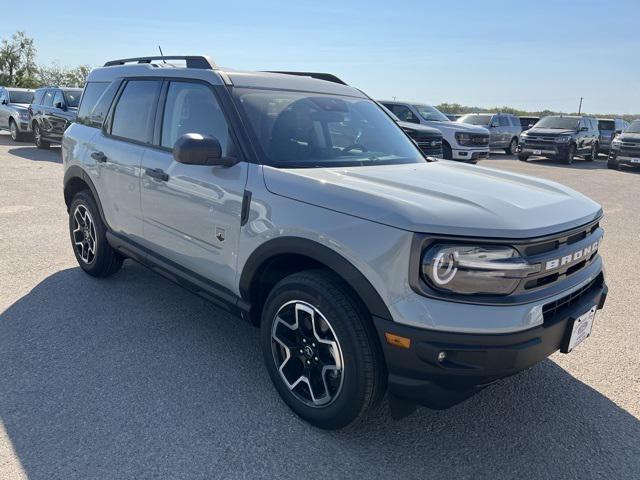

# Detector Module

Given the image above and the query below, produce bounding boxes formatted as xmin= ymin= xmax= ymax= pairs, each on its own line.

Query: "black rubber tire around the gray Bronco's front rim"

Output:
xmin=260 ymin=270 xmax=386 ymax=430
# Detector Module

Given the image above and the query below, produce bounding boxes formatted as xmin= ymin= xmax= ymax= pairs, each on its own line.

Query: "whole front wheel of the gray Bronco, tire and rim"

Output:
xmin=261 ymin=270 xmax=386 ymax=429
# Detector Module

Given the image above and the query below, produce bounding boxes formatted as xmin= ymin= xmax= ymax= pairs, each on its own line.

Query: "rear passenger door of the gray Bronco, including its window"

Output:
xmin=87 ymin=79 xmax=162 ymax=242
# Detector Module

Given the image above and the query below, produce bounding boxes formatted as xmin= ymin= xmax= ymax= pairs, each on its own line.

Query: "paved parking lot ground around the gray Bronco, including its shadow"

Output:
xmin=0 ymin=129 xmax=640 ymax=480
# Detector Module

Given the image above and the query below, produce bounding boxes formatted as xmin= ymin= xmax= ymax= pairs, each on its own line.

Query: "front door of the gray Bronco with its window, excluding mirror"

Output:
xmin=141 ymin=81 xmax=248 ymax=289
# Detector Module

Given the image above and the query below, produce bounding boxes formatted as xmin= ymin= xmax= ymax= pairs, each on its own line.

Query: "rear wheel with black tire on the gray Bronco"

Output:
xmin=69 ymin=190 xmax=124 ymax=277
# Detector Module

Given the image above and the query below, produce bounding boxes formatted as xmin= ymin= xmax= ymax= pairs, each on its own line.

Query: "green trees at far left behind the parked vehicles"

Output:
xmin=0 ymin=30 xmax=91 ymax=88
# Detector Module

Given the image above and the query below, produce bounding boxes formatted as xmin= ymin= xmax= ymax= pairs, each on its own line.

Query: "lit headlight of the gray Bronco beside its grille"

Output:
xmin=422 ymin=244 xmax=540 ymax=295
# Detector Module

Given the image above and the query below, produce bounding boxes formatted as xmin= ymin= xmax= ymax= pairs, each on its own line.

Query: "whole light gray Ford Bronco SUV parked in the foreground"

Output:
xmin=62 ymin=57 xmax=607 ymax=428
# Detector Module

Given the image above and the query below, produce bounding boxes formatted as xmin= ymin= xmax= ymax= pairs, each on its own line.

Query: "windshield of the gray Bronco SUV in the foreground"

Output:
xmin=235 ymin=89 xmax=425 ymax=168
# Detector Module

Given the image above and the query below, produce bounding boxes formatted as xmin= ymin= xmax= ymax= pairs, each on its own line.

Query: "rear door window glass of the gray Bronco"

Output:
xmin=111 ymin=80 xmax=162 ymax=142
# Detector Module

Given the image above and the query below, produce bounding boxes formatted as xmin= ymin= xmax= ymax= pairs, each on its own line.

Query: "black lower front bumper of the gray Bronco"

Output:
xmin=374 ymin=274 xmax=607 ymax=409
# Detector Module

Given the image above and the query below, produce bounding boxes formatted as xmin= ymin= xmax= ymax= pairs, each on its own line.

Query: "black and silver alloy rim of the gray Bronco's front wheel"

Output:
xmin=271 ymin=300 xmax=344 ymax=407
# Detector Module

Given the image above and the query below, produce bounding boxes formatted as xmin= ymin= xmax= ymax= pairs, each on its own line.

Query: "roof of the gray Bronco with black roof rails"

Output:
xmin=87 ymin=56 xmax=367 ymax=98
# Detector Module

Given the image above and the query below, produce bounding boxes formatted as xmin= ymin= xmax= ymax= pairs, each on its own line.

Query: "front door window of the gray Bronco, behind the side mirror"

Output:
xmin=161 ymin=82 xmax=229 ymax=152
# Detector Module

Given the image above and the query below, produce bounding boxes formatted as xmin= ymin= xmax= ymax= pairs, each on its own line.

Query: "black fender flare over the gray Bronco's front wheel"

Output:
xmin=239 ymin=237 xmax=393 ymax=320
